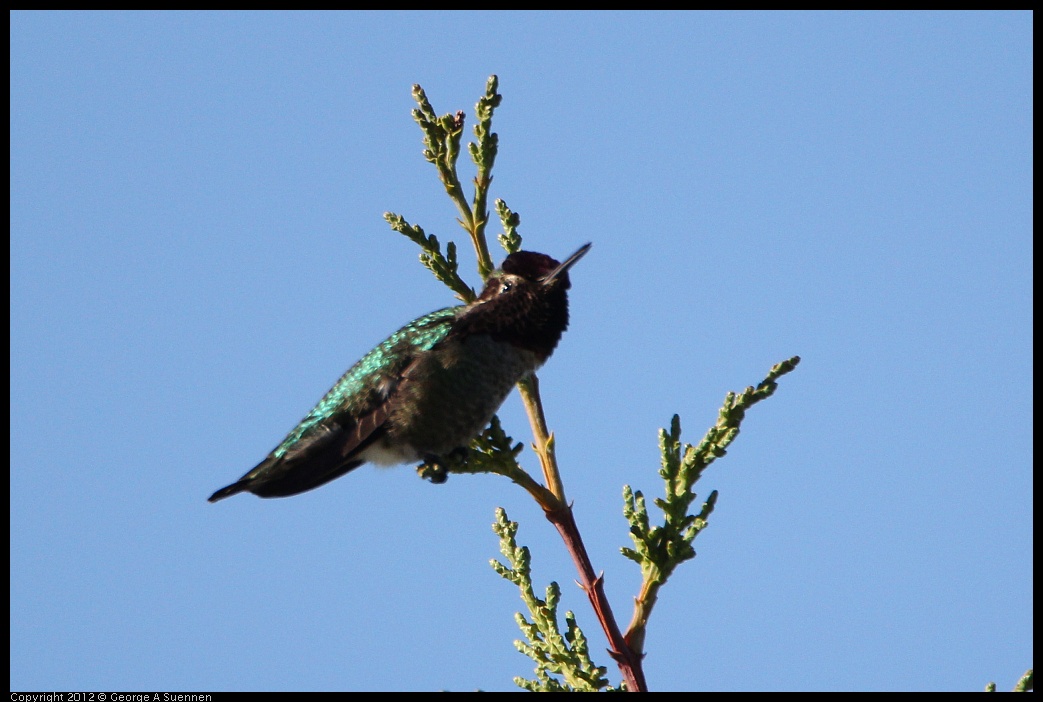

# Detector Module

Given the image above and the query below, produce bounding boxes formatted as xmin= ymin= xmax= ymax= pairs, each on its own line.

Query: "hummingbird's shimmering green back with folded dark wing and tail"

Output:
xmin=210 ymin=308 xmax=457 ymax=502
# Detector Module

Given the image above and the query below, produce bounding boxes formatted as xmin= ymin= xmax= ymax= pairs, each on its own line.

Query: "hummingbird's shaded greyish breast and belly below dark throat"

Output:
xmin=366 ymin=334 xmax=542 ymax=463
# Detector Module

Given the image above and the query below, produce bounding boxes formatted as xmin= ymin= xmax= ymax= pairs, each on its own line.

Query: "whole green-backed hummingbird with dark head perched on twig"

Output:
xmin=210 ymin=243 xmax=590 ymax=502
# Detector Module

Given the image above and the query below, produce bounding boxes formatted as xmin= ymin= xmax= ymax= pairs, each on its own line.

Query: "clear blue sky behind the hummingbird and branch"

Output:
xmin=10 ymin=13 xmax=1033 ymax=692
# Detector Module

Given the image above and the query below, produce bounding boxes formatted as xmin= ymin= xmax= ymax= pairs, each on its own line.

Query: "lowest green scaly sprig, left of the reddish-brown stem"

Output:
xmin=489 ymin=508 xmax=612 ymax=693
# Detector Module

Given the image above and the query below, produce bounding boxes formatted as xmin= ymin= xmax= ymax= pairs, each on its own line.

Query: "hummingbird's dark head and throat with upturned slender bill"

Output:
xmin=459 ymin=244 xmax=590 ymax=360
